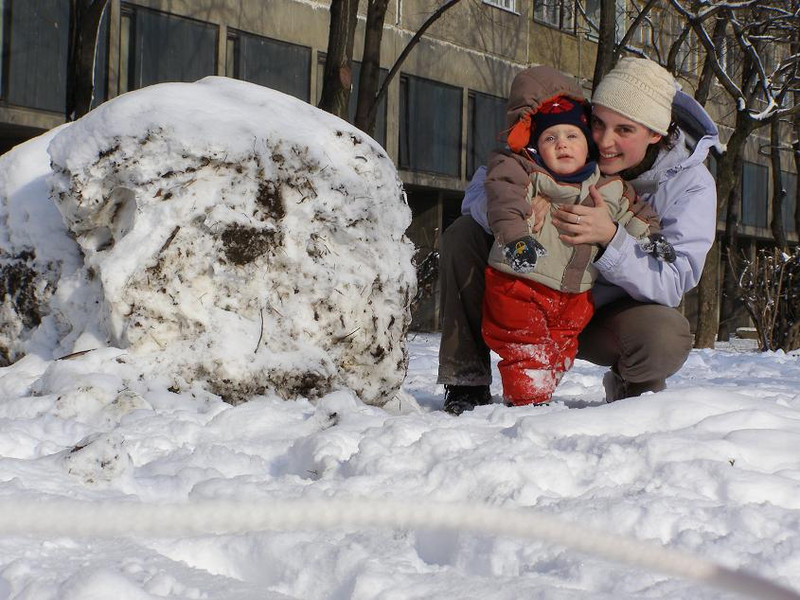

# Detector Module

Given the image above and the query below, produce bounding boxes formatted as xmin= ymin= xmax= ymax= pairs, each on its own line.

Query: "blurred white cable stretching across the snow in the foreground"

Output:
xmin=0 ymin=498 xmax=800 ymax=600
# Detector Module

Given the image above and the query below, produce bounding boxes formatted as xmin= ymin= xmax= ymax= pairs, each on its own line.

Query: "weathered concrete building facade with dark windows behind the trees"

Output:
xmin=0 ymin=0 xmax=797 ymax=329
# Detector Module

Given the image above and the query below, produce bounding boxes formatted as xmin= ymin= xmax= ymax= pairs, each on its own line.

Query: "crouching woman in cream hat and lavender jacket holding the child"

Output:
xmin=438 ymin=58 xmax=719 ymax=415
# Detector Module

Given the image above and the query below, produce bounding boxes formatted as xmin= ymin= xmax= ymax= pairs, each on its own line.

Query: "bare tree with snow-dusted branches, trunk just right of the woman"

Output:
xmin=670 ymin=0 xmax=798 ymax=348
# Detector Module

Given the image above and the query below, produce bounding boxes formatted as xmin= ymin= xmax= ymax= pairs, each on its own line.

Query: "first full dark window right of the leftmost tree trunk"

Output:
xmin=119 ymin=4 xmax=218 ymax=93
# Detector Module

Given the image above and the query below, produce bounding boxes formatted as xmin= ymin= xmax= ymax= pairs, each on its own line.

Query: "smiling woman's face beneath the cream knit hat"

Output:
xmin=592 ymin=106 xmax=661 ymax=175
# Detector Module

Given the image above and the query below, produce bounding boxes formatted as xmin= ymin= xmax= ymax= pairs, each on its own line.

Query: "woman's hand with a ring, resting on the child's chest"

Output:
xmin=552 ymin=185 xmax=617 ymax=248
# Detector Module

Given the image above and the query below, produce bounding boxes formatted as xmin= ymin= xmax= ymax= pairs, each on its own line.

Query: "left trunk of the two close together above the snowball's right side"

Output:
xmin=318 ymin=0 xmax=358 ymax=120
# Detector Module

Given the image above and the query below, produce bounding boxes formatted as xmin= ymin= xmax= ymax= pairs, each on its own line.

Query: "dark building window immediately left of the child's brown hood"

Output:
xmin=467 ymin=91 xmax=506 ymax=178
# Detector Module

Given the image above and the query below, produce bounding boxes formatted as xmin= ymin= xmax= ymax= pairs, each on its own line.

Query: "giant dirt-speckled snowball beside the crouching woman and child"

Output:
xmin=48 ymin=77 xmax=416 ymax=405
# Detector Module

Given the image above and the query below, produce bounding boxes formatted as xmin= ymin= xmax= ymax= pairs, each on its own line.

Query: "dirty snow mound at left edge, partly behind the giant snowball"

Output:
xmin=0 ymin=129 xmax=96 ymax=366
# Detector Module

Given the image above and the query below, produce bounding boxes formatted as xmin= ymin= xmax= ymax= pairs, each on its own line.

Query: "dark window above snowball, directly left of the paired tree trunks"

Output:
xmin=225 ymin=30 xmax=311 ymax=102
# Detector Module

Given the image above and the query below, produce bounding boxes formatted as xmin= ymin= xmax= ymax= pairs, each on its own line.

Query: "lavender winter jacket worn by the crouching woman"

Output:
xmin=461 ymin=91 xmax=719 ymax=307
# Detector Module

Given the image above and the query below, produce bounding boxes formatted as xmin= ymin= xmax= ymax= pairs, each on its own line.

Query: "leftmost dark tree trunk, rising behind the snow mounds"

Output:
xmin=64 ymin=0 xmax=108 ymax=121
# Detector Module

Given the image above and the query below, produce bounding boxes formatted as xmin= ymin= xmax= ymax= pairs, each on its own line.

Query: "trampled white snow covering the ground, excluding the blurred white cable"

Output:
xmin=0 ymin=334 xmax=800 ymax=600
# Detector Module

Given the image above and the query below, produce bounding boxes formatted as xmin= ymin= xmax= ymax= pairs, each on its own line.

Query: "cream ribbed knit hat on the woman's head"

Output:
xmin=592 ymin=58 xmax=677 ymax=135
